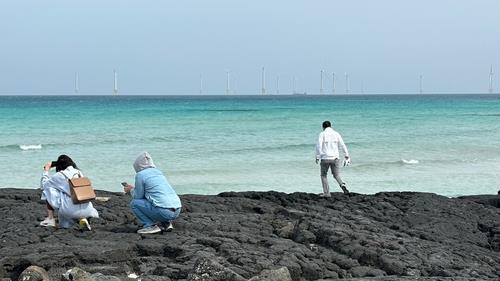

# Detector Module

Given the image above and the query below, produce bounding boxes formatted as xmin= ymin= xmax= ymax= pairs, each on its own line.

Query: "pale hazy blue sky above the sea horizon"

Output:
xmin=0 ymin=0 xmax=500 ymax=95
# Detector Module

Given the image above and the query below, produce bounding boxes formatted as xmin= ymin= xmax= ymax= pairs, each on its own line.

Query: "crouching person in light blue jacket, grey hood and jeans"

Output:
xmin=124 ymin=152 xmax=181 ymax=234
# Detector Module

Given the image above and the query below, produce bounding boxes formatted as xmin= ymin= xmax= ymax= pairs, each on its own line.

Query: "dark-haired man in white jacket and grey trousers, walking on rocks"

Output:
xmin=316 ymin=121 xmax=350 ymax=197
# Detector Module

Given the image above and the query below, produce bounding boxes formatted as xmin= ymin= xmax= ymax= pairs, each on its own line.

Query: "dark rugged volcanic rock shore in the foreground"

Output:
xmin=0 ymin=189 xmax=500 ymax=281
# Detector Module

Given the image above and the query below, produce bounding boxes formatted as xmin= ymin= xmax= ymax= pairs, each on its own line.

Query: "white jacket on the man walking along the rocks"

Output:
xmin=316 ymin=127 xmax=349 ymax=160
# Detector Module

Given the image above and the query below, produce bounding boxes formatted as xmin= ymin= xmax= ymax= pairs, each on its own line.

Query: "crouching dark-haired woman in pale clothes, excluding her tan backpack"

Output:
xmin=40 ymin=155 xmax=99 ymax=230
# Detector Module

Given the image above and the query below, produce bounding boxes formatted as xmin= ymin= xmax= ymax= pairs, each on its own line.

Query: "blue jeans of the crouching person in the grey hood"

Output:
xmin=130 ymin=199 xmax=181 ymax=227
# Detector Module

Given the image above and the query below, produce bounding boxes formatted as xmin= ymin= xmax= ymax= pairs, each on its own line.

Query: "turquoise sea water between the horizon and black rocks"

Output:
xmin=0 ymin=95 xmax=500 ymax=196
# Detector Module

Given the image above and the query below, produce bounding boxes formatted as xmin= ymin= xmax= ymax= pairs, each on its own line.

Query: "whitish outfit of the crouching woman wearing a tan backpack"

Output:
xmin=40 ymin=166 xmax=99 ymax=228
